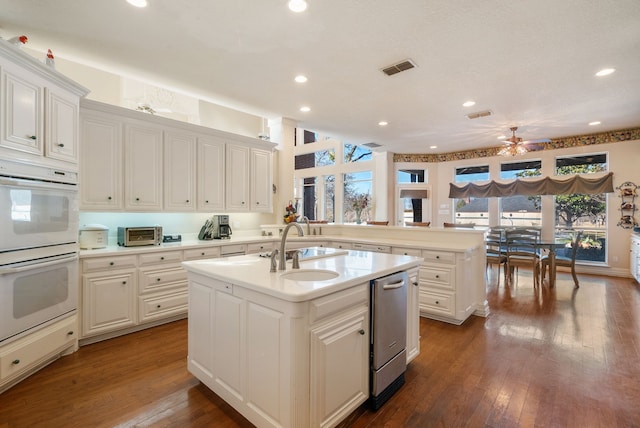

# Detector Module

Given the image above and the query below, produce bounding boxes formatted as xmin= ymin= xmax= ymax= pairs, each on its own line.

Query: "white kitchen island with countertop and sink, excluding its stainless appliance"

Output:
xmin=182 ymin=248 xmax=422 ymax=427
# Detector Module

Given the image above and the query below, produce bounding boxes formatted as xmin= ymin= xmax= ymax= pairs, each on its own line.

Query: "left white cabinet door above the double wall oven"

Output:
xmin=1 ymin=71 xmax=44 ymax=155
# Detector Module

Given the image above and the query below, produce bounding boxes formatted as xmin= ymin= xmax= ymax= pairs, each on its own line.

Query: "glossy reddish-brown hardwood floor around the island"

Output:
xmin=0 ymin=268 xmax=640 ymax=428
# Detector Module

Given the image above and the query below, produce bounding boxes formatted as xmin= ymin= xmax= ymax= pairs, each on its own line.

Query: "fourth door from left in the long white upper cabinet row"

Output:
xmin=197 ymin=138 xmax=225 ymax=212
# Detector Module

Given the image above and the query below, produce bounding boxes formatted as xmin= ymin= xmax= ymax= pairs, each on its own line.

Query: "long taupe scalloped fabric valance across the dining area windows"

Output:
xmin=449 ymin=172 xmax=613 ymax=198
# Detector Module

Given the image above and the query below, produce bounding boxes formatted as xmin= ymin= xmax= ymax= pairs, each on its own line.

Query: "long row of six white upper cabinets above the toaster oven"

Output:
xmin=80 ymin=100 xmax=275 ymax=212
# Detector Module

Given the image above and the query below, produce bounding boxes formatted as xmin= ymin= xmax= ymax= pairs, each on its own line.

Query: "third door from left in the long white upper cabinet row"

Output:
xmin=164 ymin=132 xmax=196 ymax=211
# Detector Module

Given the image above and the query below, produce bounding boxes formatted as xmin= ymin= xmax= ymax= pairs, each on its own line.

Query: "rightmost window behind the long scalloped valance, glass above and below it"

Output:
xmin=554 ymin=154 xmax=608 ymax=263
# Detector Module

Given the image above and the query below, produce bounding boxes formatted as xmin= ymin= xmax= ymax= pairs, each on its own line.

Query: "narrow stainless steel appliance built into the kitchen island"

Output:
xmin=369 ymin=272 xmax=409 ymax=409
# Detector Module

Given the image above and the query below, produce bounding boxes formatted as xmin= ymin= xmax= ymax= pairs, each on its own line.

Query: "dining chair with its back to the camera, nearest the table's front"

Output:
xmin=505 ymin=228 xmax=540 ymax=286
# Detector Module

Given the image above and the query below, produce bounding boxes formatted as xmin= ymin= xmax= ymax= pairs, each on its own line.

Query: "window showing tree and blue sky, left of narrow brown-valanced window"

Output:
xmin=343 ymin=171 xmax=373 ymax=223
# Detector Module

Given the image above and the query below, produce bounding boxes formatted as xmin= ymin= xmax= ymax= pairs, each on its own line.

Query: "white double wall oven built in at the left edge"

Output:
xmin=0 ymin=160 xmax=79 ymax=345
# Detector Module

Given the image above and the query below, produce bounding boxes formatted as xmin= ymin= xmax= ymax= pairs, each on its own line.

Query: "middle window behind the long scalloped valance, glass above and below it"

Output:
xmin=500 ymin=160 xmax=542 ymax=227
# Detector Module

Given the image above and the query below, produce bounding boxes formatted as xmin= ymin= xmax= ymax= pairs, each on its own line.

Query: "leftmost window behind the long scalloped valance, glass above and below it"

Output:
xmin=453 ymin=165 xmax=489 ymax=226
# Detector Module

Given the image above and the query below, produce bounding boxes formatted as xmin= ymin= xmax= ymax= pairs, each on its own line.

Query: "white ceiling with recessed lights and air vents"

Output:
xmin=0 ymin=0 xmax=640 ymax=153
